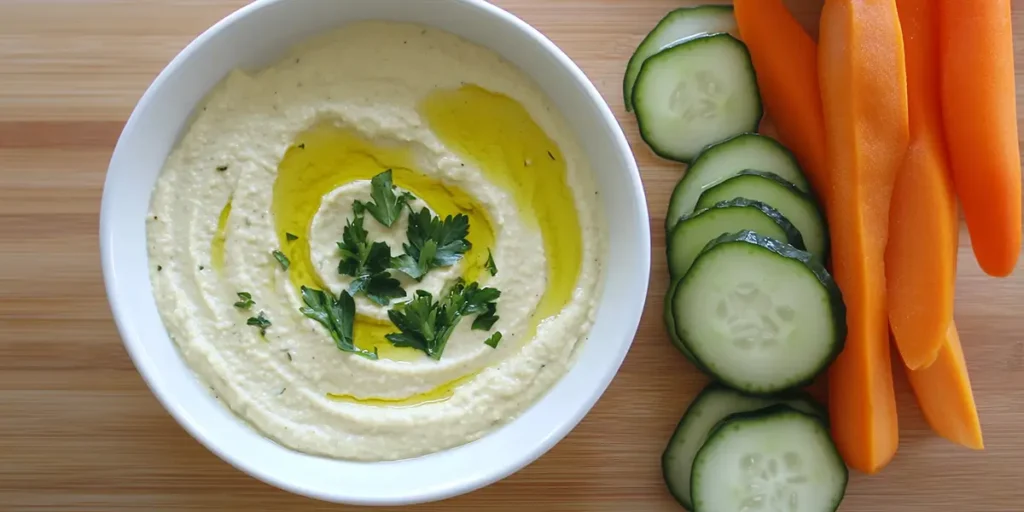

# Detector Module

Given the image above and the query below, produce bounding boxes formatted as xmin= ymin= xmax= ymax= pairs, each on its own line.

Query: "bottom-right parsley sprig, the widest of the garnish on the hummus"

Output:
xmin=385 ymin=281 xmax=501 ymax=359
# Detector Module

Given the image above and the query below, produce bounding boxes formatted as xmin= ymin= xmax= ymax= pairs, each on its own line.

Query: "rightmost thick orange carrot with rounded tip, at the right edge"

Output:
xmin=935 ymin=0 xmax=1021 ymax=276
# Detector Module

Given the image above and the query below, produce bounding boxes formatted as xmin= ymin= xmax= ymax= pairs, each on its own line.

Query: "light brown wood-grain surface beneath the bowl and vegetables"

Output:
xmin=0 ymin=0 xmax=1024 ymax=512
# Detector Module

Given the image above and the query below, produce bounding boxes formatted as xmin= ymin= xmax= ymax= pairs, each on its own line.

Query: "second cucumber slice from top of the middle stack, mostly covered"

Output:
xmin=696 ymin=170 xmax=828 ymax=261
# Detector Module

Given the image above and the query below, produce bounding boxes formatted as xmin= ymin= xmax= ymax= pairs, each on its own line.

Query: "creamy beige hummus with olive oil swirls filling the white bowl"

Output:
xmin=146 ymin=22 xmax=604 ymax=461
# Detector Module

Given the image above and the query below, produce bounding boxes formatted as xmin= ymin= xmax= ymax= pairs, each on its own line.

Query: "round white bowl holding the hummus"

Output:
xmin=100 ymin=0 xmax=650 ymax=505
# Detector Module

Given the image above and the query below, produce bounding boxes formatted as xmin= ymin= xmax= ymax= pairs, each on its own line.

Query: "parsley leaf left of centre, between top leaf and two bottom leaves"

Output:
xmin=338 ymin=213 xmax=406 ymax=306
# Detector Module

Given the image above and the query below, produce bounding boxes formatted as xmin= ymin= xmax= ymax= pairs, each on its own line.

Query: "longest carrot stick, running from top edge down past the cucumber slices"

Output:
xmin=818 ymin=0 xmax=909 ymax=473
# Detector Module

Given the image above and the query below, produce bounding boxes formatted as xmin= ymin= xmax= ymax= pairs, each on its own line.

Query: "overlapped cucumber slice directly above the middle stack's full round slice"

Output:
xmin=668 ymin=198 xmax=804 ymax=280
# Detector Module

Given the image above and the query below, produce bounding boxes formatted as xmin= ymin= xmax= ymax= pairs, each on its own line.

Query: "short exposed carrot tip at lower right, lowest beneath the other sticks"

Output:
xmin=907 ymin=323 xmax=985 ymax=450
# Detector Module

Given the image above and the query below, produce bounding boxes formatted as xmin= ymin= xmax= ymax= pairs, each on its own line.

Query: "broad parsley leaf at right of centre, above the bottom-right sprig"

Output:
xmin=391 ymin=208 xmax=472 ymax=280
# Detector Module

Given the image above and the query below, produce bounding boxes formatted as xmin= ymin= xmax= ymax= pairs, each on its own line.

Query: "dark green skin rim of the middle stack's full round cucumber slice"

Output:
xmin=673 ymin=230 xmax=847 ymax=395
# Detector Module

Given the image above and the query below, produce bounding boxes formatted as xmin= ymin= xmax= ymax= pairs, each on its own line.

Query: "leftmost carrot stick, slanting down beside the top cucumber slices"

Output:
xmin=732 ymin=0 xmax=830 ymax=204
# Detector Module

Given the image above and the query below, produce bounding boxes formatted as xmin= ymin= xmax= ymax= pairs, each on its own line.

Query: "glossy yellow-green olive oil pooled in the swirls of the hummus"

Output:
xmin=213 ymin=85 xmax=583 ymax=407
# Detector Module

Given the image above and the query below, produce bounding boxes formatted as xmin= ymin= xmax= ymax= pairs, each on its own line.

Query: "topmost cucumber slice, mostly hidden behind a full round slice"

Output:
xmin=623 ymin=5 xmax=737 ymax=112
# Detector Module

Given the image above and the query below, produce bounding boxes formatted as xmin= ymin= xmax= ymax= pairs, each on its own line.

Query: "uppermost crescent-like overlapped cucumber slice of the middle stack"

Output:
xmin=666 ymin=133 xmax=810 ymax=229
